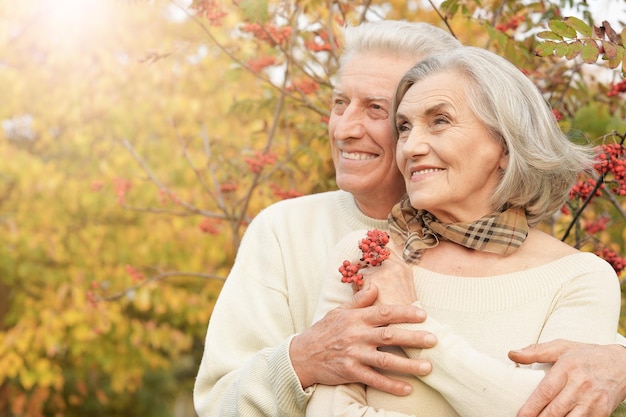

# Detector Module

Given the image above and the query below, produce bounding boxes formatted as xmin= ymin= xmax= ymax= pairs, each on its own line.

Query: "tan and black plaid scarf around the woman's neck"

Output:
xmin=387 ymin=197 xmax=528 ymax=264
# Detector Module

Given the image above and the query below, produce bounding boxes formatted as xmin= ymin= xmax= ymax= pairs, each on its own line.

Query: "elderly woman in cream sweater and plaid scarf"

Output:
xmin=307 ymin=47 xmax=620 ymax=417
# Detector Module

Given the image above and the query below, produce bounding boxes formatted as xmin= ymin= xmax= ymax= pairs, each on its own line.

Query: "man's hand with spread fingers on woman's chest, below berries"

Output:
xmin=289 ymin=285 xmax=436 ymax=395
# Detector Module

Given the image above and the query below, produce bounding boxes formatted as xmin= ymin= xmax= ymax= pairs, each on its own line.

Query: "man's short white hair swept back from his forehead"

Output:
xmin=340 ymin=20 xmax=461 ymax=72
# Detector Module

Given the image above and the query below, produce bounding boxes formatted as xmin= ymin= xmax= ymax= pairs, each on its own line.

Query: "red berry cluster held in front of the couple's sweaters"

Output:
xmin=339 ymin=229 xmax=391 ymax=287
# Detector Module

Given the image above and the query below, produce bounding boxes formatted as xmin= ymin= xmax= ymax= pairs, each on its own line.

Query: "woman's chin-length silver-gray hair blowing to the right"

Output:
xmin=390 ymin=46 xmax=595 ymax=226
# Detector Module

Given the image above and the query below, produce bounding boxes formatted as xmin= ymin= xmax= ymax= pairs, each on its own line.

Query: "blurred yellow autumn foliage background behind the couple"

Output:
xmin=0 ymin=0 xmax=626 ymax=417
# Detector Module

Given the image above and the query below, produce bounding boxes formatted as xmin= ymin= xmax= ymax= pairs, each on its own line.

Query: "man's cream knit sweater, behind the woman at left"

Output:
xmin=194 ymin=191 xmax=387 ymax=417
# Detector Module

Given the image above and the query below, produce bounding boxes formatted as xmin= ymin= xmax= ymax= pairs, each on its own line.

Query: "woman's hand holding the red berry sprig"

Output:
xmin=359 ymin=255 xmax=417 ymax=305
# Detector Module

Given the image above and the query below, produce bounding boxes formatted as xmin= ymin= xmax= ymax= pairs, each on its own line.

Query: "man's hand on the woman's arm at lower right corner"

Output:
xmin=509 ymin=340 xmax=626 ymax=417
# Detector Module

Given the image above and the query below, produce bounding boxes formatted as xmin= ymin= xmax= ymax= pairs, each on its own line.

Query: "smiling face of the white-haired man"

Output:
xmin=328 ymin=54 xmax=414 ymax=217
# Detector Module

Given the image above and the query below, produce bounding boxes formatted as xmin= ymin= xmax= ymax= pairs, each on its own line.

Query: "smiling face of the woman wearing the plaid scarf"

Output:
xmin=395 ymin=71 xmax=508 ymax=223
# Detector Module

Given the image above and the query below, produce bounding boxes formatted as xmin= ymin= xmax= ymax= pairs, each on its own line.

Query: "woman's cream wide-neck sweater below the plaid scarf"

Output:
xmin=307 ymin=231 xmax=620 ymax=417
